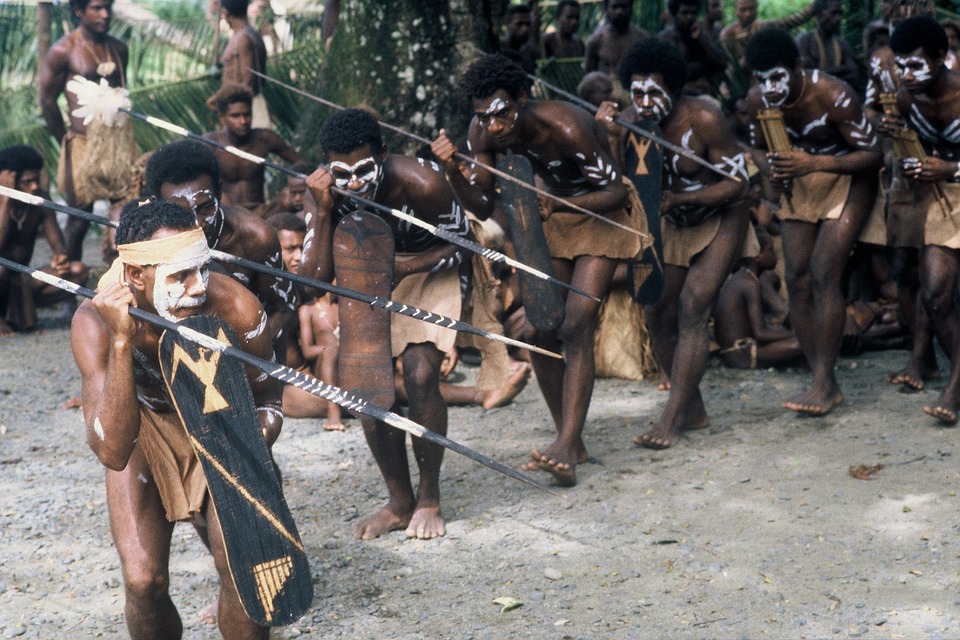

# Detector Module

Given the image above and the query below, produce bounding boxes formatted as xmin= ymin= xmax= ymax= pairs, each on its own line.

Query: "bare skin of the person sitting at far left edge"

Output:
xmin=0 ymin=170 xmax=87 ymax=337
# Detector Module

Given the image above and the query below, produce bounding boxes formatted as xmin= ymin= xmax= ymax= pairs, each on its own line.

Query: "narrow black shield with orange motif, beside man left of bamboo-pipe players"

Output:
xmin=624 ymin=121 xmax=663 ymax=304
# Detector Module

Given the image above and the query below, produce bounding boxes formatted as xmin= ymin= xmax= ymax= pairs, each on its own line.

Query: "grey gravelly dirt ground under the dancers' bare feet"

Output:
xmin=0 ymin=236 xmax=960 ymax=640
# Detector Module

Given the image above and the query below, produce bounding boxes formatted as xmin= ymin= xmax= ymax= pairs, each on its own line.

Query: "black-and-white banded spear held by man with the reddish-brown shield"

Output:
xmin=119 ymin=107 xmax=600 ymax=302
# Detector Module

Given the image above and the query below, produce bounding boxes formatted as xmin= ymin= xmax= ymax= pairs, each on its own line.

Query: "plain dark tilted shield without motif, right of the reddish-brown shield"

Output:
xmin=497 ymin=155 xmax=564 ymax=331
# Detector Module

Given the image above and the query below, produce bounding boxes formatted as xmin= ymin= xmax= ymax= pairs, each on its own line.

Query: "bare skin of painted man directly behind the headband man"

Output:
xmin=160 ymin=174 xmax=294 ymax=348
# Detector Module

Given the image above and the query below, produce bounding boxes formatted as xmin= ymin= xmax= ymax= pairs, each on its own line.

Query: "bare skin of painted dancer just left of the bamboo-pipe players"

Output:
xmin=597 ymin=73 xmax=750 ymax=449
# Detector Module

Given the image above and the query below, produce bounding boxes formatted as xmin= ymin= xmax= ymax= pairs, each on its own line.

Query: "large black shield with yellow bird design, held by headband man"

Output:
xmin=160 ymin=316 xmax=313 ymax=626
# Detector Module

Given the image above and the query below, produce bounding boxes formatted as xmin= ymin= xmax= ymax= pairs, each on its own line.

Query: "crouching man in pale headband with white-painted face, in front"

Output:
xmin=71 ymin=203 xmax=282 ymax=638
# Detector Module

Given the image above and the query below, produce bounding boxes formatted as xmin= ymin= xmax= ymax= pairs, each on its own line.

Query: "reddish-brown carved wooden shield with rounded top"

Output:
xmin=333 ymin=212 xmax=394 ymax=418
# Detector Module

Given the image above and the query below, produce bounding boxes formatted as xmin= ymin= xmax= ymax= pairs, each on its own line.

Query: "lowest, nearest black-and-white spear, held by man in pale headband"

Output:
xmin=0 ymin=258 xmax=565 ymax=497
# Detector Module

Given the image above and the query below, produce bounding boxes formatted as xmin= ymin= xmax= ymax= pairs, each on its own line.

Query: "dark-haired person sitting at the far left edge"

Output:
xmin=0 ymin=145 xmax=87 ymax=336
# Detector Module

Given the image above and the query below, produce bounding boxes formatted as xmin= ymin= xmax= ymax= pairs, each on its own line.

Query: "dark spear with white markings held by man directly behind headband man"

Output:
xmin=0 ymin=185 xmax=562 ymax=358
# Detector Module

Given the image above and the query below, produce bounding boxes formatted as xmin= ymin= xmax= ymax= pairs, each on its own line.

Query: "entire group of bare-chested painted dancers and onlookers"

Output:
xmin=9 ymin=0 xmax=960 ymax=638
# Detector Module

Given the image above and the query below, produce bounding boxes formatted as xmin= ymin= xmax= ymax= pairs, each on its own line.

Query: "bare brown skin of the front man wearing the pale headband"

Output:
xmin=71 ymin=229 xmax=280 ymax=639
